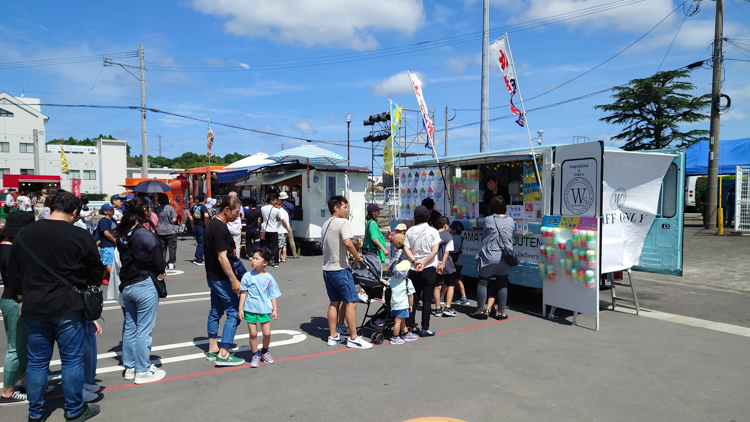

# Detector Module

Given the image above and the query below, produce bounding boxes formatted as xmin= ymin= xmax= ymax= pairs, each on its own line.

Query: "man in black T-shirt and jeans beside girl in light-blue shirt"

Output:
xmin=204 ymin=196 xmax=245 ymax=366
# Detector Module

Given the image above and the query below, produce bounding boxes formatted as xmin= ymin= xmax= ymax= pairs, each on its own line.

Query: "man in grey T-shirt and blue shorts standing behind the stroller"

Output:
xmin=321 ymin=196 xmax=372 ymax=349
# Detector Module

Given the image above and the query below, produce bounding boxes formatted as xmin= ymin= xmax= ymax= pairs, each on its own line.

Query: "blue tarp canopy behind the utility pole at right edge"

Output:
xmin=685 ymin=138 xmax=750 ymax=176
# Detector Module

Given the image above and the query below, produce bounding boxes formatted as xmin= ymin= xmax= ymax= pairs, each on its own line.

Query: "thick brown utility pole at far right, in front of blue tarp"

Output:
xmin=703 ymin=0 xmax=724 ymax=229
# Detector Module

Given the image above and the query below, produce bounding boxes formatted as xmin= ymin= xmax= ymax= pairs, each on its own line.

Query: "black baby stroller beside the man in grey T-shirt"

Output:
xmin=352 ymin=253 xmax=395 ymax=344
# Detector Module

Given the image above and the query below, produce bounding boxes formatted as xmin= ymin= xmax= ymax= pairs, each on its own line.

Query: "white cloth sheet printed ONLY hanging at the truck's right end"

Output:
xmin=602 ymin=151 xmax=674 ymax=273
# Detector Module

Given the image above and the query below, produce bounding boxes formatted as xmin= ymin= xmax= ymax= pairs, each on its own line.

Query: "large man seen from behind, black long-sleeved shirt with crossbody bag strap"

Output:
xmin=9 ymin=192 xmax=104 ymax=421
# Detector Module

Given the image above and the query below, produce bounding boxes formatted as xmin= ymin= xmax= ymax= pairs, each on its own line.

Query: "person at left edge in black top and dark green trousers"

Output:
xmin=0 ymin=211 xmax=34 ymax=406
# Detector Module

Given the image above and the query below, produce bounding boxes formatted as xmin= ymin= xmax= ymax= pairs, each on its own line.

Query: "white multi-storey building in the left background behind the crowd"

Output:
xmin=0 ymin=92 xmax=172 ymax=195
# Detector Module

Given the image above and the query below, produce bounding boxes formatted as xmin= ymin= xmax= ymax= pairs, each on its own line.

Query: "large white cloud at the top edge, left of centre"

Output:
xmin=191 ymin=0 xmax=425 ymax=50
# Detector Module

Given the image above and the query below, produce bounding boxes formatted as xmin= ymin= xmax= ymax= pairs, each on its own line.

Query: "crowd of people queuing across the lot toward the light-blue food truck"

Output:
xmin=0 ymin=186 xmax=514 ymax=421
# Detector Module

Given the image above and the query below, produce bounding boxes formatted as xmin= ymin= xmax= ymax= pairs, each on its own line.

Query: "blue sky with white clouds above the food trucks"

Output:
xmin=0 ymin=0 xmax=750 ymax=170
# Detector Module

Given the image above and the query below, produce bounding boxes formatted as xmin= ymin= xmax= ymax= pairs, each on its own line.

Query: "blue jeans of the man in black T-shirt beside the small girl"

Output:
xmin=206 ymin=280 xmax=240 ymax=349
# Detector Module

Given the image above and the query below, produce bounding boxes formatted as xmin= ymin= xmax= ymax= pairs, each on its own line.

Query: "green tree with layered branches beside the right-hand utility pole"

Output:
xmin=594 ymin=70 xmax=711 ymax=151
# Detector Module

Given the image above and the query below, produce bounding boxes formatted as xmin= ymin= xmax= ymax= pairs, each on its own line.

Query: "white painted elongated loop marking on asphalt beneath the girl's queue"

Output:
xmin=36 ymin=330 xmax=307 ymax=380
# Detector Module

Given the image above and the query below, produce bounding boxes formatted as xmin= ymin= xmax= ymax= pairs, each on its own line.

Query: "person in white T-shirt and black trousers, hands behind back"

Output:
xmin=404 ymin=205 xmax=440 ymax=337
